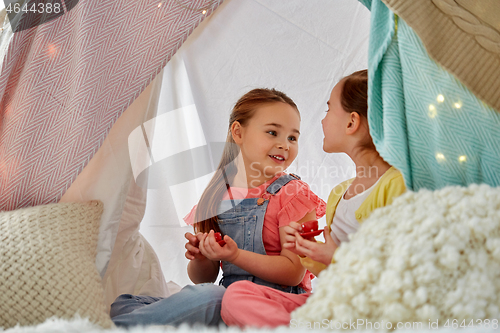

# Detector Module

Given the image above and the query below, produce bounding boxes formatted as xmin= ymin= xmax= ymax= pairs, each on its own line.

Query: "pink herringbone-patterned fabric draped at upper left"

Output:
xmin=0 ymin=0 xmax=223 ymax=210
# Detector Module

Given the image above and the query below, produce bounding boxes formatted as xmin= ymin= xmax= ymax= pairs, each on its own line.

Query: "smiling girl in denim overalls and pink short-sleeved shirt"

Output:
xmin=111 ymin=89 xmax=325 ymax=326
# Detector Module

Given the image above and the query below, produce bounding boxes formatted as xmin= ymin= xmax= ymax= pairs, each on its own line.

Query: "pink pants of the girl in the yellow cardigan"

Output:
xmin=221 ymin=281 xmax=311 ymax=327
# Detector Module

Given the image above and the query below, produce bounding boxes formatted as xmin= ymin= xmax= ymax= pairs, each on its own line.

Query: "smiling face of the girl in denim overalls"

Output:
xmin=231 ymin=102 xmax=300 ymax=187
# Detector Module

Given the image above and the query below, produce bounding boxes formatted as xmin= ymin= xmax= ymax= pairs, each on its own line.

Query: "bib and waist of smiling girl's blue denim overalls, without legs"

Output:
xmin=218 ymin=175 xmax=305 ymax=294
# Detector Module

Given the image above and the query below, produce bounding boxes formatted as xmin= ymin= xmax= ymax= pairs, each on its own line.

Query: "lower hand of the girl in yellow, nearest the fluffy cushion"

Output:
xmin=295 ymin=227 xmax=337 ymax=265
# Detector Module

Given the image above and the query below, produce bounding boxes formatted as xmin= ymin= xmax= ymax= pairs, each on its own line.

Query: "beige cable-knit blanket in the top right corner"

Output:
xmin=383 ymin=0 xmax=500 ymax=112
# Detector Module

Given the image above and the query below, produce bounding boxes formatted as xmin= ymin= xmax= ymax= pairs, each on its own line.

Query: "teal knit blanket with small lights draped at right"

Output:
xmin=360 ymin=0 xmax=500 ymax=191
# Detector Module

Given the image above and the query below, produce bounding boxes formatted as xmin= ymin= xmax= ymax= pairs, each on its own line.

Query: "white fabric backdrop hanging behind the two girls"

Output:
xmin=140 ymin=0 xmax=370 ymax=286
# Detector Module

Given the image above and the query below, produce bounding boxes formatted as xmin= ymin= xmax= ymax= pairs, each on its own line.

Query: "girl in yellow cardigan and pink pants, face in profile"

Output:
xmin=222 ymin=70 xmax=406 ymax=327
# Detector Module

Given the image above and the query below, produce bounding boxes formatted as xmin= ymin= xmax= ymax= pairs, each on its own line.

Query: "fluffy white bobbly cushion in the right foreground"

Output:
xmin=292 ymin=185 xmax=500 ymax=329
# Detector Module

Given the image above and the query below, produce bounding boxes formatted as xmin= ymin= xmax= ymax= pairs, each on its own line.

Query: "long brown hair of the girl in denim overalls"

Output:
xmin=194 ymin=88 xmax=299 ymax=232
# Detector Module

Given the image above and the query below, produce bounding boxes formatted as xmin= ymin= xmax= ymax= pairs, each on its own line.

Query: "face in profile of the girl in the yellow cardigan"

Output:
xmin=321 ymin=81 xmax=350 ymax=153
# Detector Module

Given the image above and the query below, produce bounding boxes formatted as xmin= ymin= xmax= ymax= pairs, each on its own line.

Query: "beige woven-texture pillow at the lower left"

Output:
xmin=0 ymin=201 xmax=114 ymax=330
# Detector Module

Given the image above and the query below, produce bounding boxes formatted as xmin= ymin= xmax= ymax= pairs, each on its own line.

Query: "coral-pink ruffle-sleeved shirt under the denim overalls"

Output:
xmin=184 ymin=173 xmax=326 ymax=291
